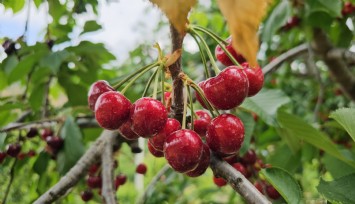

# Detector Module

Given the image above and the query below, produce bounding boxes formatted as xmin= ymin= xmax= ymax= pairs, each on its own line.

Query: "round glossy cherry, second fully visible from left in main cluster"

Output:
xmin=130 ymin=97 xmax=168 ymax=138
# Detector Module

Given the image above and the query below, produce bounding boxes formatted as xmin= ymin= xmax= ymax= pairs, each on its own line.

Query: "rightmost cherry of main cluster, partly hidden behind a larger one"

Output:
xmin=242 ymin=62 xmax=264 ymax=96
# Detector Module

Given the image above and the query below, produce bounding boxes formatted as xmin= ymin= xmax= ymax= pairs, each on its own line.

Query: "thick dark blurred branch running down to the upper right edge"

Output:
xmin=312 ymin=28 xmax=355 ymax=101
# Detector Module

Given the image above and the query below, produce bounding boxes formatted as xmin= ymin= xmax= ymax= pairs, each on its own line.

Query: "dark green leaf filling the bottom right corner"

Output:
xmin=317 ymin=174 xmax=355 ymax=204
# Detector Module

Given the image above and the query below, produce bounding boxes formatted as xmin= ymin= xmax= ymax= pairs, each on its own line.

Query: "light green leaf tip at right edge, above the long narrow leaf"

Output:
xmin=329 ymin=108 xmax=355 ymax=141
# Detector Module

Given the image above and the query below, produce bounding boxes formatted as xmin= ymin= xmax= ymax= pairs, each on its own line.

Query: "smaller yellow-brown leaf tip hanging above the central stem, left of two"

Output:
xmin=150 ymin=0 xmax=196 ymax=34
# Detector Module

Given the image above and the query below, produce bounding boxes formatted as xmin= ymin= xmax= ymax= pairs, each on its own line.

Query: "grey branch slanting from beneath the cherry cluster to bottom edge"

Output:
xmin=210 ymin=153 xmax=271 ymax=204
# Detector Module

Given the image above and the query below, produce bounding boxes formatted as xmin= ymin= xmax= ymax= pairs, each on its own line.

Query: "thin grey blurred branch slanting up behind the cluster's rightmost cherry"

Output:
xmin=263 ymin=44 xmax=308 ymax=74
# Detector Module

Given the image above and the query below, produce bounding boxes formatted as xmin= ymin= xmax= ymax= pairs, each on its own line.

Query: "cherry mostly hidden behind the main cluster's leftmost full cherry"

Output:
xmin=88 ymin=80 xmax=115 ymax=111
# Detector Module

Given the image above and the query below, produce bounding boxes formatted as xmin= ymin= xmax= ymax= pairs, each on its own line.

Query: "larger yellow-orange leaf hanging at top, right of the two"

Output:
xmin=217 ymin=0 xmax=269 ymax=66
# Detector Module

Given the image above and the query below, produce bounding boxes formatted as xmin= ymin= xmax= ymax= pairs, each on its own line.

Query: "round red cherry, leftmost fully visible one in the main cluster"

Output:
xmin=95 ymin=91 xmax=131 ymax=130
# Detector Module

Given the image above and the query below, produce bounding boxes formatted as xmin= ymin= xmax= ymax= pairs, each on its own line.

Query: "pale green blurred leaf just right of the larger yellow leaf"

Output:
xmin=261 ymin=0 xmax=291 ymax=42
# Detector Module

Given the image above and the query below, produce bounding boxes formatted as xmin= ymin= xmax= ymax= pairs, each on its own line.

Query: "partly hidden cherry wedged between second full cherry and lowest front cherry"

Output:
xmin=149 ymin=118 xmax=181 ymax=151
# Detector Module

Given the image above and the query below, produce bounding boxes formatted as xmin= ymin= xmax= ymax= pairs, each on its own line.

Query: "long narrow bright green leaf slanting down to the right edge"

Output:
xmin=277 ymin=111 xmax=355 ymax=166
